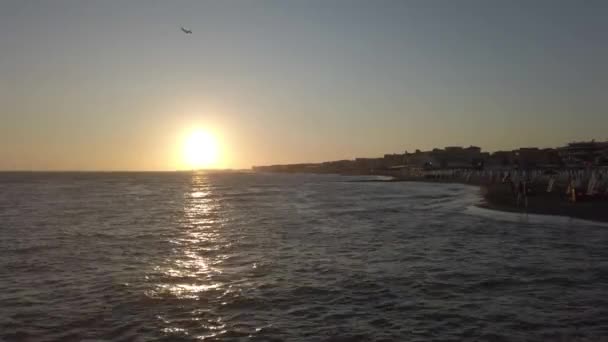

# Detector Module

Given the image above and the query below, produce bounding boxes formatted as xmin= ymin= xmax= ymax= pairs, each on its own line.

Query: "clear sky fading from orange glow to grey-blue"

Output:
xmin=0 ymin=0 xmax=608 ymax=170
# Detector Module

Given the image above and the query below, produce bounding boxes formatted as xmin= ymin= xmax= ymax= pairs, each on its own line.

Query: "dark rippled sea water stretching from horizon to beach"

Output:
xmin=0 ymin=173 xmax=608 ymax=341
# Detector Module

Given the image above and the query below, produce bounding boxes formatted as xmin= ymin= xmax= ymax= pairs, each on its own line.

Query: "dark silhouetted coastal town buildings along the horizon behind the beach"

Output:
xmin=253 ymin=140 xmax=608 ymax=174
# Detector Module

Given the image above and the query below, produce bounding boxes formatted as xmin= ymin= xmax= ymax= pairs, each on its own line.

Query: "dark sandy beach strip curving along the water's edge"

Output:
xmin=346 ymin=175 xmax=608 ymax=223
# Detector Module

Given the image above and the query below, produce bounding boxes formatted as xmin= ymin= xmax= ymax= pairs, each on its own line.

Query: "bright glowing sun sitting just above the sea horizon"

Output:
xmin=184 ymin=130 xmax=218 ymax=169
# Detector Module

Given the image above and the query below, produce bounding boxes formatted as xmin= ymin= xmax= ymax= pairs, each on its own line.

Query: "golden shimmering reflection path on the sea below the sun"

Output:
xmin=147 ymin=173 xmax=234 ymax=339
